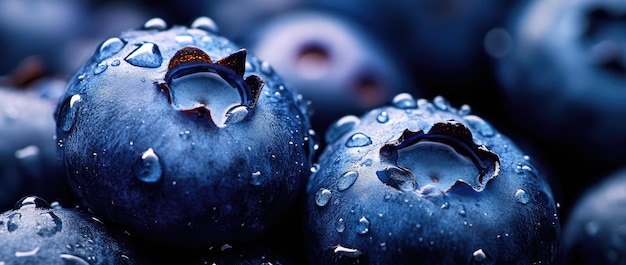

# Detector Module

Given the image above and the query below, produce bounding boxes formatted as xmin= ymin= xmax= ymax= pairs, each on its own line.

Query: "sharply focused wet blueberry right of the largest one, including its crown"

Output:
xmin=303 ymin=94 xmax=560 ymax=264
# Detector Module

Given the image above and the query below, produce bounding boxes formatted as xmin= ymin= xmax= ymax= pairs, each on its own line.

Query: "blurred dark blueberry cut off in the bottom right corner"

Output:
xmin=559 ymin=168 xmax=626 ymax=264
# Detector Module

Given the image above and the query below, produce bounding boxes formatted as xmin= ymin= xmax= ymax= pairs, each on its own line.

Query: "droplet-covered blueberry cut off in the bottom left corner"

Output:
xmin=0 ymin=196 xmax=145 ymax=264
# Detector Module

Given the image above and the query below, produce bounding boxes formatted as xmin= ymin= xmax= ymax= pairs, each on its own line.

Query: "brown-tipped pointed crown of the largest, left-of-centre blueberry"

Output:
xmin=157 ymin=46 xmax=265 ymax=127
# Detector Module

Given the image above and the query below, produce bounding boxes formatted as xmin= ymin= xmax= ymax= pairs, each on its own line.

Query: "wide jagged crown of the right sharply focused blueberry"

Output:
xmin=376 ymin=120 xmax=500 ymax=192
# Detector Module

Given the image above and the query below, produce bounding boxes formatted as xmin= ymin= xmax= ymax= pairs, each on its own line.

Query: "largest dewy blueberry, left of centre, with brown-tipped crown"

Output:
xmin=56 ymin=18 xmax=315 ymax=247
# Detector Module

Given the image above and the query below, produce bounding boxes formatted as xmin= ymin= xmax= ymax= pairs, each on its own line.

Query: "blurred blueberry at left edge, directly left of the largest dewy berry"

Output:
xmin=0 ymin=79 xmax=73 ymax=212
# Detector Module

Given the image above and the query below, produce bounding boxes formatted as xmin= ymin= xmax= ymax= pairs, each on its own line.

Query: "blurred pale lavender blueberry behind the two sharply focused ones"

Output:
xmin=236 ymin=8 xmax=418 ymax=135
